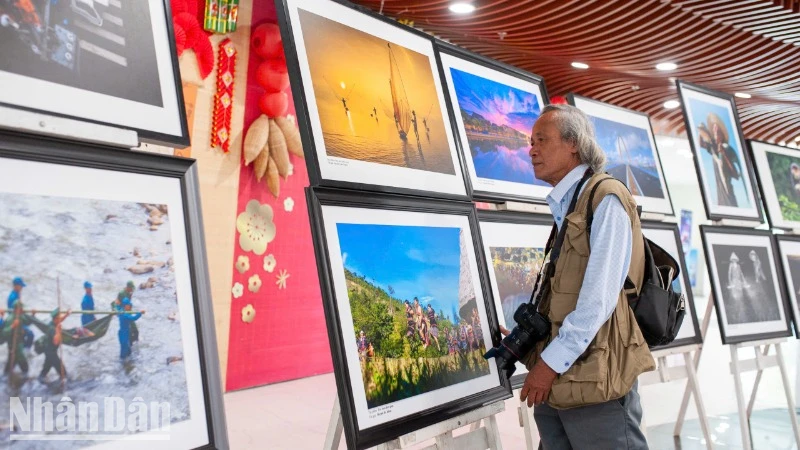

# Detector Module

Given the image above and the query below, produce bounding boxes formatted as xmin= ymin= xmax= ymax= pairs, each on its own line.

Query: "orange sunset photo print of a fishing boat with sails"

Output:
xmin=297 ymin=8 xmax=457 ymax=175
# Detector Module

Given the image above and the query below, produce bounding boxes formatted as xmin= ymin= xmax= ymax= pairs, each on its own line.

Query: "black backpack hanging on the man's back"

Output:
xmin=586 ymin=177 xmax=686 ymax=348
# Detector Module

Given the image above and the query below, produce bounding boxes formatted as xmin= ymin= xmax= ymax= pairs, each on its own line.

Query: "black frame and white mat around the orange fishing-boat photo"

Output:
xmin=275 ymin=0 xmax=471 ymax=200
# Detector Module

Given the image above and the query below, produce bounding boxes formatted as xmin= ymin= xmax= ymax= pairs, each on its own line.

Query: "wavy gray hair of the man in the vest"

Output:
xmin=541 ymin=105 xmax=606 ymax=173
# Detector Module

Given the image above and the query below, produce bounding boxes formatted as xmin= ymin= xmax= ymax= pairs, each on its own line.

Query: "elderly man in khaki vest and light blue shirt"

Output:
xmin=501 ymin=105 xmax=655 ymax=450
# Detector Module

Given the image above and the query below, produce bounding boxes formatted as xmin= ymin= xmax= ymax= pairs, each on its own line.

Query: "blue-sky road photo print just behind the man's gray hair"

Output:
xmin=589 ymin=116 xmax=664 ymax=198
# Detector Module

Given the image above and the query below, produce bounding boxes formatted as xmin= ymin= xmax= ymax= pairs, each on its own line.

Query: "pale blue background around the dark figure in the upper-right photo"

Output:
xmin=689 ymin=98 xmax=750 ymax=208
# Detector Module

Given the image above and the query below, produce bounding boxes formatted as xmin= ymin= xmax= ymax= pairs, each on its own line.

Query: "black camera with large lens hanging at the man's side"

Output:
xmin=483 ymin=303 xmax=550 ymax=378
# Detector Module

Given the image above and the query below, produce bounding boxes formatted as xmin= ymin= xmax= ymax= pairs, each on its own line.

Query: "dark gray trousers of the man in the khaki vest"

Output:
xmin=533 ymin=381 xmax=648 ymax=450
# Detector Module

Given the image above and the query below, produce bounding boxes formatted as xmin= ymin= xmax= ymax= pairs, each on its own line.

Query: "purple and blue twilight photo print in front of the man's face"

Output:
xmin=450 ymin=68 xmax=547 ymax=186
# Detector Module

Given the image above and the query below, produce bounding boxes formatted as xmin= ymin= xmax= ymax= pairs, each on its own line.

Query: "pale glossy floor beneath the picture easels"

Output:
xmin=225 ymin=374 xmax=797 ymax=450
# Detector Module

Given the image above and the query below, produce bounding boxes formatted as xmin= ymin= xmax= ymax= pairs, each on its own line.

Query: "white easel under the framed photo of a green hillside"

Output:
xmin=322 ymin=395 xmax=506 ymax=450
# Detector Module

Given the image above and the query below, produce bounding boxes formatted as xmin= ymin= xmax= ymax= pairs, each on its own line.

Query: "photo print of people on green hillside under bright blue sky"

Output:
xmin=337 ymin=223 xmax=490 ymax=408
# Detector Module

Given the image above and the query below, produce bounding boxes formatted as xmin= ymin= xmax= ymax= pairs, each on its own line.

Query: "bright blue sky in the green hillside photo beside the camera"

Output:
xmin=337 ymin=223 xmax=461 ymax=317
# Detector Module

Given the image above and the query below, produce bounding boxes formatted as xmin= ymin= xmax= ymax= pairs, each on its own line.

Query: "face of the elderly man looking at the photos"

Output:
xmin=528 ymin=113 xmax=580 ymax=186
